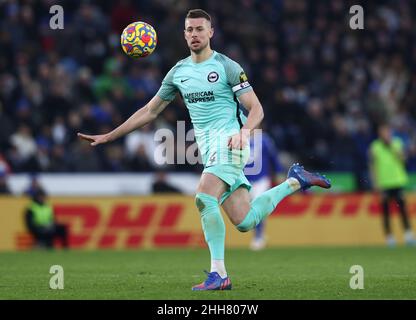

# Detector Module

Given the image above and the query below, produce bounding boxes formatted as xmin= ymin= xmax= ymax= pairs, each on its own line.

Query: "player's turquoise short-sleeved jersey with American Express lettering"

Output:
xmin=157 ymin=51 xmax=252 ymax=164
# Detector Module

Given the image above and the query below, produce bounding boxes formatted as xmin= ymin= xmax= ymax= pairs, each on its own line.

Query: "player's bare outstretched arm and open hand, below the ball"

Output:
xmin=78 ymin=96 xmax=170 ymax=146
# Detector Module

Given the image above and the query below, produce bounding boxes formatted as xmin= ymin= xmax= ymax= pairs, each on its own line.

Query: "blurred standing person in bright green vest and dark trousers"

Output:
xmin=370 ymin=124 xmax=416 ymax=246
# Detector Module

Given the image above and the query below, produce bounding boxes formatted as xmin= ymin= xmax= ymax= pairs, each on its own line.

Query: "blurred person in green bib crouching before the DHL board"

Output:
xmin=25 ymin=188 xmax=68 ymax=249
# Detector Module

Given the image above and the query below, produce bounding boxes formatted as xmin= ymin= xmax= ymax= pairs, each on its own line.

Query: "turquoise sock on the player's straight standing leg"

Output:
xmin=195 ymin=193 xmax=225 ymax=260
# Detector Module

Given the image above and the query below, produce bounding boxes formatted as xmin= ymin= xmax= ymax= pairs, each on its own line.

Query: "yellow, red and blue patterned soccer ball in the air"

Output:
xmin=120 ymin=21 xmax=157 ymax=58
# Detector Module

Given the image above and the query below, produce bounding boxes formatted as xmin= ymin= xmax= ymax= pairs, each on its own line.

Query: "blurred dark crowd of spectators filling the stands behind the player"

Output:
xmin=0 ymin=0 xmax=416 ymax=189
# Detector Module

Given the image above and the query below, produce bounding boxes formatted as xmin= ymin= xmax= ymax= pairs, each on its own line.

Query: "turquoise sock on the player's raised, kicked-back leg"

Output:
xmin=236 ymin=178 xmax=300 ymax=232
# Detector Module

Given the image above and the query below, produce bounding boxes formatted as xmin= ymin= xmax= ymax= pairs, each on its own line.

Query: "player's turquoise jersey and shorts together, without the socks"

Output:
xmin=157 ymin=51 xmax=253 ymax=203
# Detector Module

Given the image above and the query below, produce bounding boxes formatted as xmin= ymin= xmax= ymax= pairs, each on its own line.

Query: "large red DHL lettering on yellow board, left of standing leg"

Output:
xmin=54 ymin=203 xmax=205 ymax=248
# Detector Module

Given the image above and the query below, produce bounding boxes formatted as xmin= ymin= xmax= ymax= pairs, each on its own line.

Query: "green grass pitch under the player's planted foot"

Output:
xmin=0 ymin=247 xmax=416 ymax=300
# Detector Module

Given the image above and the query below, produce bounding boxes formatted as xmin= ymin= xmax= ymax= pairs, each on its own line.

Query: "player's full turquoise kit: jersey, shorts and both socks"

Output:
xmin=156 ymin=51 xmax=294 ymax=268
